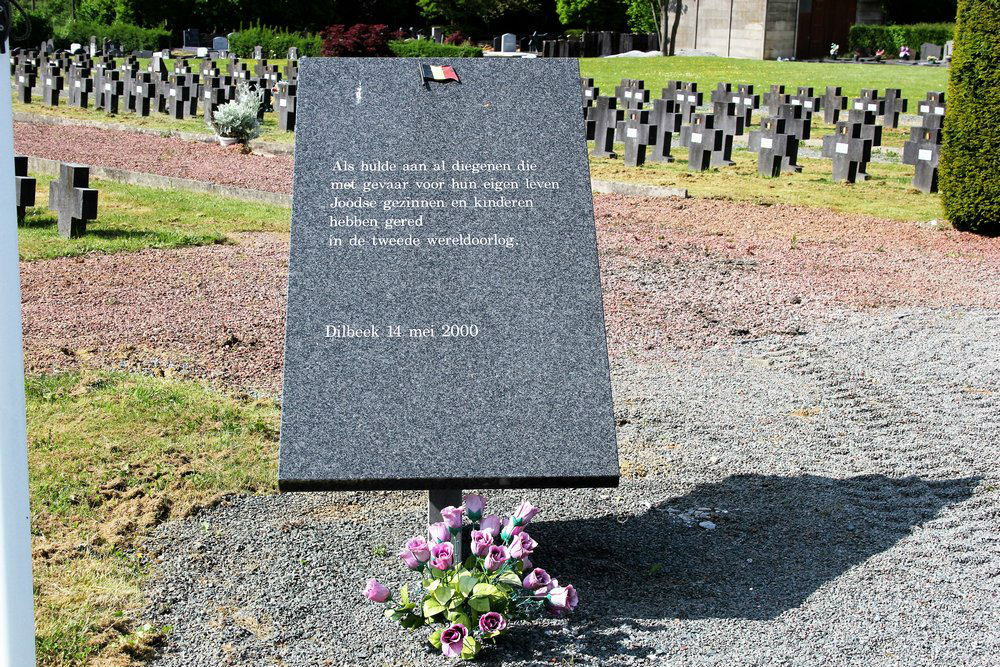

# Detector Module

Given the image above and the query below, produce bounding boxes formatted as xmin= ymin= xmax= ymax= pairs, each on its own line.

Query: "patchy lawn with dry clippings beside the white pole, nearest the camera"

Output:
xmin=26 ymin=372 xmax=280 ymax=667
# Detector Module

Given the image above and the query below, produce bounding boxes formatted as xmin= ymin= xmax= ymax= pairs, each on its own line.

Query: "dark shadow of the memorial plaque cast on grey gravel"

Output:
xmin=531 ymin=475 xmax=979 ymax=640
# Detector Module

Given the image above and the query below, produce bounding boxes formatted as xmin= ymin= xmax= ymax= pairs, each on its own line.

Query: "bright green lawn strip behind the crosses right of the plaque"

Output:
xmin=580 ymin=56 xmax=948 ymax=107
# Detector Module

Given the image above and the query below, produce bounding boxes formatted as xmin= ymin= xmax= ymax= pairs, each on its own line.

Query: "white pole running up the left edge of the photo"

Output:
xmin=0 ymin=28 xmax=35 ymax=667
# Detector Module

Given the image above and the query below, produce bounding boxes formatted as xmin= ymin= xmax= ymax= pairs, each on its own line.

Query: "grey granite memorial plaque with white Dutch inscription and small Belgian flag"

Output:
xmin=278 ymin=58 xmax=619 ymax=493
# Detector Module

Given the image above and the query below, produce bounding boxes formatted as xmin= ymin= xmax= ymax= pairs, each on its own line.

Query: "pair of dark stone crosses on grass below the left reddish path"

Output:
xmin=14 ymin=155 xmax=97 ymax=238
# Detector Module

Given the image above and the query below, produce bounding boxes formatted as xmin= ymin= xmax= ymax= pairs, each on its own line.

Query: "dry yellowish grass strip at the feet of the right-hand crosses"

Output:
xmin=590 ymin=147 xmax=944 ymax=222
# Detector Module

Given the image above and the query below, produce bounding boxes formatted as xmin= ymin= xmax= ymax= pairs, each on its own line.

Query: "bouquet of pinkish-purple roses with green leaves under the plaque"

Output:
xmin=363 ymin=495 xmax=577 ymax=660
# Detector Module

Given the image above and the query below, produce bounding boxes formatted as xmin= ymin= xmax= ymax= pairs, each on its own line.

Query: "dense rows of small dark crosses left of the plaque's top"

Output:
xmin=10 ymin=47 xmax=298 ymax=132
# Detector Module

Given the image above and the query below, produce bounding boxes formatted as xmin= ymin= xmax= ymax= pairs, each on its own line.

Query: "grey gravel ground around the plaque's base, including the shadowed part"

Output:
xmin=141 ymin=309 xmax=1000 ymax=667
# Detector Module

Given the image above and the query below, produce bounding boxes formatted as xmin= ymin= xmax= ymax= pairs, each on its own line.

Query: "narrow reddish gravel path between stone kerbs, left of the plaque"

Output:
xmin=14 ymin=123 xmax=292 ymax=194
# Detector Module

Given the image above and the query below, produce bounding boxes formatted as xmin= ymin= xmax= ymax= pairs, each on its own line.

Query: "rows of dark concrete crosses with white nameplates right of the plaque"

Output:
xmin=580 ymin=79 xmax=944 ymax=192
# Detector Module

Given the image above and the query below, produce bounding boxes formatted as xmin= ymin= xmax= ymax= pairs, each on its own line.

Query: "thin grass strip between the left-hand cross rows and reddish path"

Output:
xmin=13 ymin=98 xmax=295 ymax=144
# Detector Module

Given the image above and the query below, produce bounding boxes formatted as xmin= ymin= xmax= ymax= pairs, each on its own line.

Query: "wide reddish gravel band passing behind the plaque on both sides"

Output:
xmin=21 ymin=195 xmax=1000 ymax=392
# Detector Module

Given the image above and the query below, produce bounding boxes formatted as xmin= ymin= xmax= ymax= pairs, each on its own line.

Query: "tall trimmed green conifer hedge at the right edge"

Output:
xmin=940 ymin=0 xmax=1000 ymax=234
